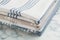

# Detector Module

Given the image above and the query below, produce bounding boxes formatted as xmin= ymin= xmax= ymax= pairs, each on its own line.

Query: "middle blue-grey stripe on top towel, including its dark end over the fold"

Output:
xmin=10 ymin=0 xmax=40 ymax=19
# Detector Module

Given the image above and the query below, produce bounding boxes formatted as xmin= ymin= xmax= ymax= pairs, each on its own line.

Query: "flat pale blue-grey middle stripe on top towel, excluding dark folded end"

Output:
xmin=18 ymin=0 xmax=40 ymax=12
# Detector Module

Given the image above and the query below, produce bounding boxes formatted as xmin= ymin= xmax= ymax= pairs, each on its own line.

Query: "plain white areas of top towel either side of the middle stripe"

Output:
xmin=0 ymin=0 xmax=55 ymax=19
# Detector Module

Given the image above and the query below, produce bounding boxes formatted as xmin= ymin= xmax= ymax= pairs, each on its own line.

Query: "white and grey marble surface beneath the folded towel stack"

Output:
xmin=0 ymin=5 xmax=60 ymax=40
